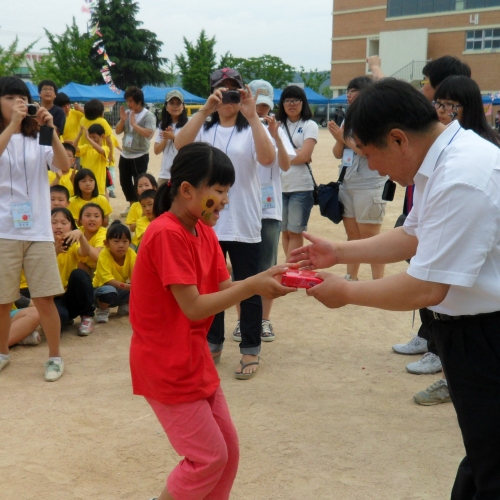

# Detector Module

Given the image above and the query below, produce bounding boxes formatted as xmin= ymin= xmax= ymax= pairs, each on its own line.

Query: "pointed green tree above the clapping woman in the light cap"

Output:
xmin=175 ymin=30 xmax=216 ymax=97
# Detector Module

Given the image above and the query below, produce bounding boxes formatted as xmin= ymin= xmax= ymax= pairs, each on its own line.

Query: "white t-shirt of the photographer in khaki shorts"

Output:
xmin=0 ymin=134 xmax=54 ymax=241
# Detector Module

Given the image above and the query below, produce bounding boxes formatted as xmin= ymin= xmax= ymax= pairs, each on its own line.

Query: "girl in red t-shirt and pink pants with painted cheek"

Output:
xmin=130 ymin=143 xmax=295 ymax=500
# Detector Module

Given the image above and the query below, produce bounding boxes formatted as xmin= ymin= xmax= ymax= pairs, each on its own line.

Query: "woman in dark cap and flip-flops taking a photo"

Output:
xmin=174 ymin=68 xmax=276 ymax=380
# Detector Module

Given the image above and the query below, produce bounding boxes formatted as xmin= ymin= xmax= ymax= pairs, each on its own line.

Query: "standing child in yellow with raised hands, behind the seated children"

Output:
xmin=76 ymin=123 xmax=109 ymax=195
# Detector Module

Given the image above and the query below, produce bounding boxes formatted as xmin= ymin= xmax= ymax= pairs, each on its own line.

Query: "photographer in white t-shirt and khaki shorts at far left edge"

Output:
xmin=0 ymin=77 xmax=69 ymax=382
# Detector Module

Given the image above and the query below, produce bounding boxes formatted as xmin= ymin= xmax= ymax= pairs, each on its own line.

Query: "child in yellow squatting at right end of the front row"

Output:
xmin=93 ymin=220 xmax=137 ymax=323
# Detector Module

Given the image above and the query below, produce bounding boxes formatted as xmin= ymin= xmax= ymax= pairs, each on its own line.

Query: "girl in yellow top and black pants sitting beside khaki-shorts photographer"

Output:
xmin=51 ymin=208 xmax=95 ymax=336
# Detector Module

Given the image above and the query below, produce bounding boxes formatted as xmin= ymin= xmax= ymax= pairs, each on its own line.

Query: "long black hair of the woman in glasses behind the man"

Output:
xmin=434 ymin=76 xmax=500 ymax=147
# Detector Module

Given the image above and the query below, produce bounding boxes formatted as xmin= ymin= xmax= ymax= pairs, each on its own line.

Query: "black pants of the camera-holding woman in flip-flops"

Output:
xmin=207 ymin=241 xmax=262 ymax=355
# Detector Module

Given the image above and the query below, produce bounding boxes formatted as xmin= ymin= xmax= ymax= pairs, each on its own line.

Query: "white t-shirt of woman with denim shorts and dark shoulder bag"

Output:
xmin=281 ymin=119 xmax=318 ymax=193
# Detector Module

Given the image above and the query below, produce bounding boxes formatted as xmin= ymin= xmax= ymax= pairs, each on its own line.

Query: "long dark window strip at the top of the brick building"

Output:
xmin=387 ymin=0 xmax=500 ymax=17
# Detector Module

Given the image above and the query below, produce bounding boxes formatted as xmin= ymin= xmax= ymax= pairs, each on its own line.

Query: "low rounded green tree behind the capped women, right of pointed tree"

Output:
xmin=220 ymin=52 xmax=295 ymax=89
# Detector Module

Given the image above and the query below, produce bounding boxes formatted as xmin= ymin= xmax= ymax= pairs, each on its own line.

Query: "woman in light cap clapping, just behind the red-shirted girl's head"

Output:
xmin=154 ymin=90 xmax=188 ymax=186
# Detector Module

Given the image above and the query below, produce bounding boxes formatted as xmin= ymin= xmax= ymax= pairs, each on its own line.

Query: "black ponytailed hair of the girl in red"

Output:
xmin=153 ymin=142 xmax=235 ymax=217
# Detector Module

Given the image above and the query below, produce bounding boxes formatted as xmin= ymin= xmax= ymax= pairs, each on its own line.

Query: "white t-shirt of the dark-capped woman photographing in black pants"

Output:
xmin=195 ymin=124 xmax=271 ymax=243
